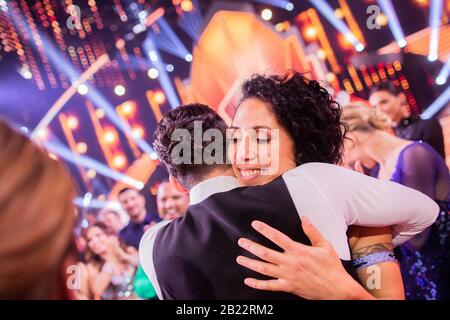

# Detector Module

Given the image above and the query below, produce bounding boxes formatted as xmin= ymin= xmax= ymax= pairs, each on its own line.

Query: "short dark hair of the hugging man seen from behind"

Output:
xmin=153 ymin=103 xmax=229 ymax=189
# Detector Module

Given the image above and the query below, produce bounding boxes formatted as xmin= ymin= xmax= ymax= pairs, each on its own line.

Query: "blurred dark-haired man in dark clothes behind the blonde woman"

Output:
xmin=369 ymin=82 xmax=445 ymax=159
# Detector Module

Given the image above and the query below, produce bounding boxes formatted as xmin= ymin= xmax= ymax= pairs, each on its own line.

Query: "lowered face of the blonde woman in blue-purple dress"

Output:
xmin=343 ymin=131 xmax=376 ymax=169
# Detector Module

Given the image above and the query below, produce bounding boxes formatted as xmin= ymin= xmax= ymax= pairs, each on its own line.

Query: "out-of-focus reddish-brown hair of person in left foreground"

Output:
xmin=0 ymin=121 xmax=76 ymax=299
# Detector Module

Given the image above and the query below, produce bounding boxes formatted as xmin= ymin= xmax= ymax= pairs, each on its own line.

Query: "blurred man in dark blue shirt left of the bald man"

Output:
xmin=118 ymin=187 xmax=152 ymax=249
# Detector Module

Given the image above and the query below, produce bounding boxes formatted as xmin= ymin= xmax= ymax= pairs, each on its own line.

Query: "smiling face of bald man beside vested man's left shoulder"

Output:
xmin=156 ymin=182 xmax=189 ymax=220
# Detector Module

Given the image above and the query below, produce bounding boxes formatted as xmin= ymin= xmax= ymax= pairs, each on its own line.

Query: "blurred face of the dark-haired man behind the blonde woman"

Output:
xmin=369 ymin=90 xmax=407 ymax=123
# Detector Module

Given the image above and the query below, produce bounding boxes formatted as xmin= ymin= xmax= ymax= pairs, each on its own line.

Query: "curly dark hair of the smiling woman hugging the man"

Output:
xmin=237 ymin=71 xmax=347 ymax=165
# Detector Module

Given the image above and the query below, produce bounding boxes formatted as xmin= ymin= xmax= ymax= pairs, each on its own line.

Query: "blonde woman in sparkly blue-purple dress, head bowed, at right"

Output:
xmin=342 ymin=105 xmax=450 ymax=300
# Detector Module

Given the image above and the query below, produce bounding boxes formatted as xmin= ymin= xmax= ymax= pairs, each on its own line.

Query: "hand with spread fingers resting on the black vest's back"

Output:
xmin=236 ymin=217 xmax=374 ymax=300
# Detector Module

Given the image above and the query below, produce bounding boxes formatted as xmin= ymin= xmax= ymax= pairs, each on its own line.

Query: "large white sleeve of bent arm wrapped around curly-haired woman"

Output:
xmin=284 ymin=163 xmax=439 ymax=246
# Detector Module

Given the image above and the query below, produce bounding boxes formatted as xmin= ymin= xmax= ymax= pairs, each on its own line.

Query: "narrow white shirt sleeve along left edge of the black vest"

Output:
xmin=139 ymin=220 xmax=171 ymax=300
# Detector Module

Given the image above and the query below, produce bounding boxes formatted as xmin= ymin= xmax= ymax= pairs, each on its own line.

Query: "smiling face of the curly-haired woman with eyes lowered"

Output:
xmin=227 ymin=98 xmax=296 ymax=186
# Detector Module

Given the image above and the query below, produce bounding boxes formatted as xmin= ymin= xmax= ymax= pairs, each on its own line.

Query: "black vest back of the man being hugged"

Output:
xmin=153 ymin=178 xmax=354 ymax=300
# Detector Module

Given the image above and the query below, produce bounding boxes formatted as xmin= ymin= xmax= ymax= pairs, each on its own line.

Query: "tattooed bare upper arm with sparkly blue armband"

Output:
xmin=347 ymin=226 xmax=405 ymax=300
